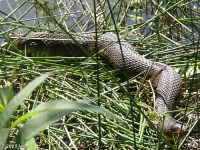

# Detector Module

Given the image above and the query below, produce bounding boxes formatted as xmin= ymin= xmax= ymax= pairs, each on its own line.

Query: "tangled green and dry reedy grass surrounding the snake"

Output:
xmin=0 ymin=0 xmax=200 ymax=149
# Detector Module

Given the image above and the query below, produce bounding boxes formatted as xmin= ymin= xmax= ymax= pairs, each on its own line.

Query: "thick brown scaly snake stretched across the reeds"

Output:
xmin=13 ymin=32 xmax=188 ymax=139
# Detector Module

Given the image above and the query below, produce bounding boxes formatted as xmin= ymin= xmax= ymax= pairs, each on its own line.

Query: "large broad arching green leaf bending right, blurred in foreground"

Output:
xmin=19 ymin=100 xmax=120 ymax=144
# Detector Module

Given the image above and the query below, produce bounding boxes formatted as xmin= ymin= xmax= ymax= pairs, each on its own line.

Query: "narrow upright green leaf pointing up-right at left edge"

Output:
xmin=0 ymin=73 xmax=50 ymax=129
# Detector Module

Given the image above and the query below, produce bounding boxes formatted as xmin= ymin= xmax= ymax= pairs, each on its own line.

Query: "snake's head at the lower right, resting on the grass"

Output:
xmin=163 ymin=117 xmax=188 ymax=141
